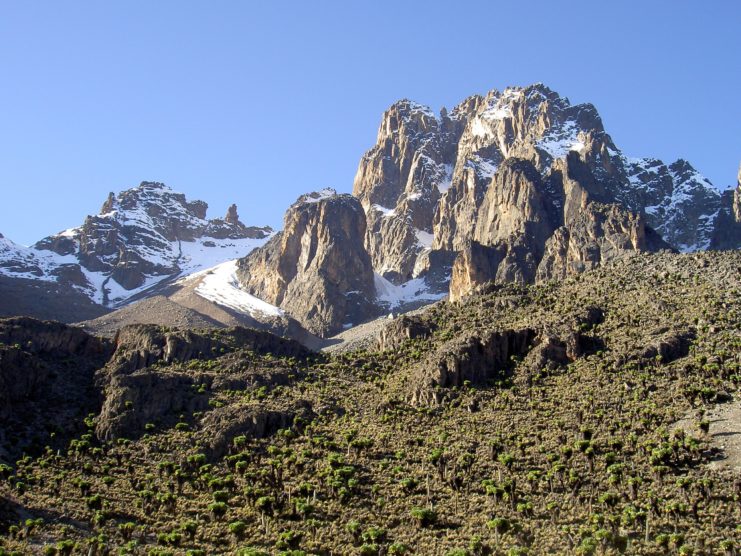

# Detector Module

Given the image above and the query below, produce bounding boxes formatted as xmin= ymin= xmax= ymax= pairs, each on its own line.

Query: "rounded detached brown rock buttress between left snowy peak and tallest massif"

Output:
xmin=237 ymin=189 xmax=375 ymax=336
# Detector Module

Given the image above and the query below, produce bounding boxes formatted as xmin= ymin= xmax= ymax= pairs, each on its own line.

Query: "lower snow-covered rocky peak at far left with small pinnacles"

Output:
xmin=0 ymin=182 xmax=272 ymax=312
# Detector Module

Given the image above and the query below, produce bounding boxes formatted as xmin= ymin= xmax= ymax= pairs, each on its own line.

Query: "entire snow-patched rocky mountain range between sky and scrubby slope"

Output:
xmin=0 ymin=84 xmax=741 ymax=337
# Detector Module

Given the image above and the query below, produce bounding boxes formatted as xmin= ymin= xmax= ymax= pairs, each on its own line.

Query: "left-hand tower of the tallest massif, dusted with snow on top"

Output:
xmin=353 ymin=100 xmax=461 ymax=283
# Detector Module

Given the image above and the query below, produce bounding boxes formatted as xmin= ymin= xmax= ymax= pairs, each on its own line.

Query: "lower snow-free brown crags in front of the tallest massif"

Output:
xmin=450 ymin=151 xmax=670 ymax=301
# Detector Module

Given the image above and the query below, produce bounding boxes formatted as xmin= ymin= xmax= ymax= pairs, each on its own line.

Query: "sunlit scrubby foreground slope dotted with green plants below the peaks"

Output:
xmin=0 ymin=251 xmax=741 ymax=554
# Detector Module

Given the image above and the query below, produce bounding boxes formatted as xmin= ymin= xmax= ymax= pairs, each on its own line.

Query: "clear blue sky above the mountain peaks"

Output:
xmin=0 ymin=0 xmax=741 ymax=244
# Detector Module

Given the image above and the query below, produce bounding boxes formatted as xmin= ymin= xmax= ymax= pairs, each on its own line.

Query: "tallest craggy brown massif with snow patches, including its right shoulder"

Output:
xmin=353 ymin=84 xmax=741 ymax=304
